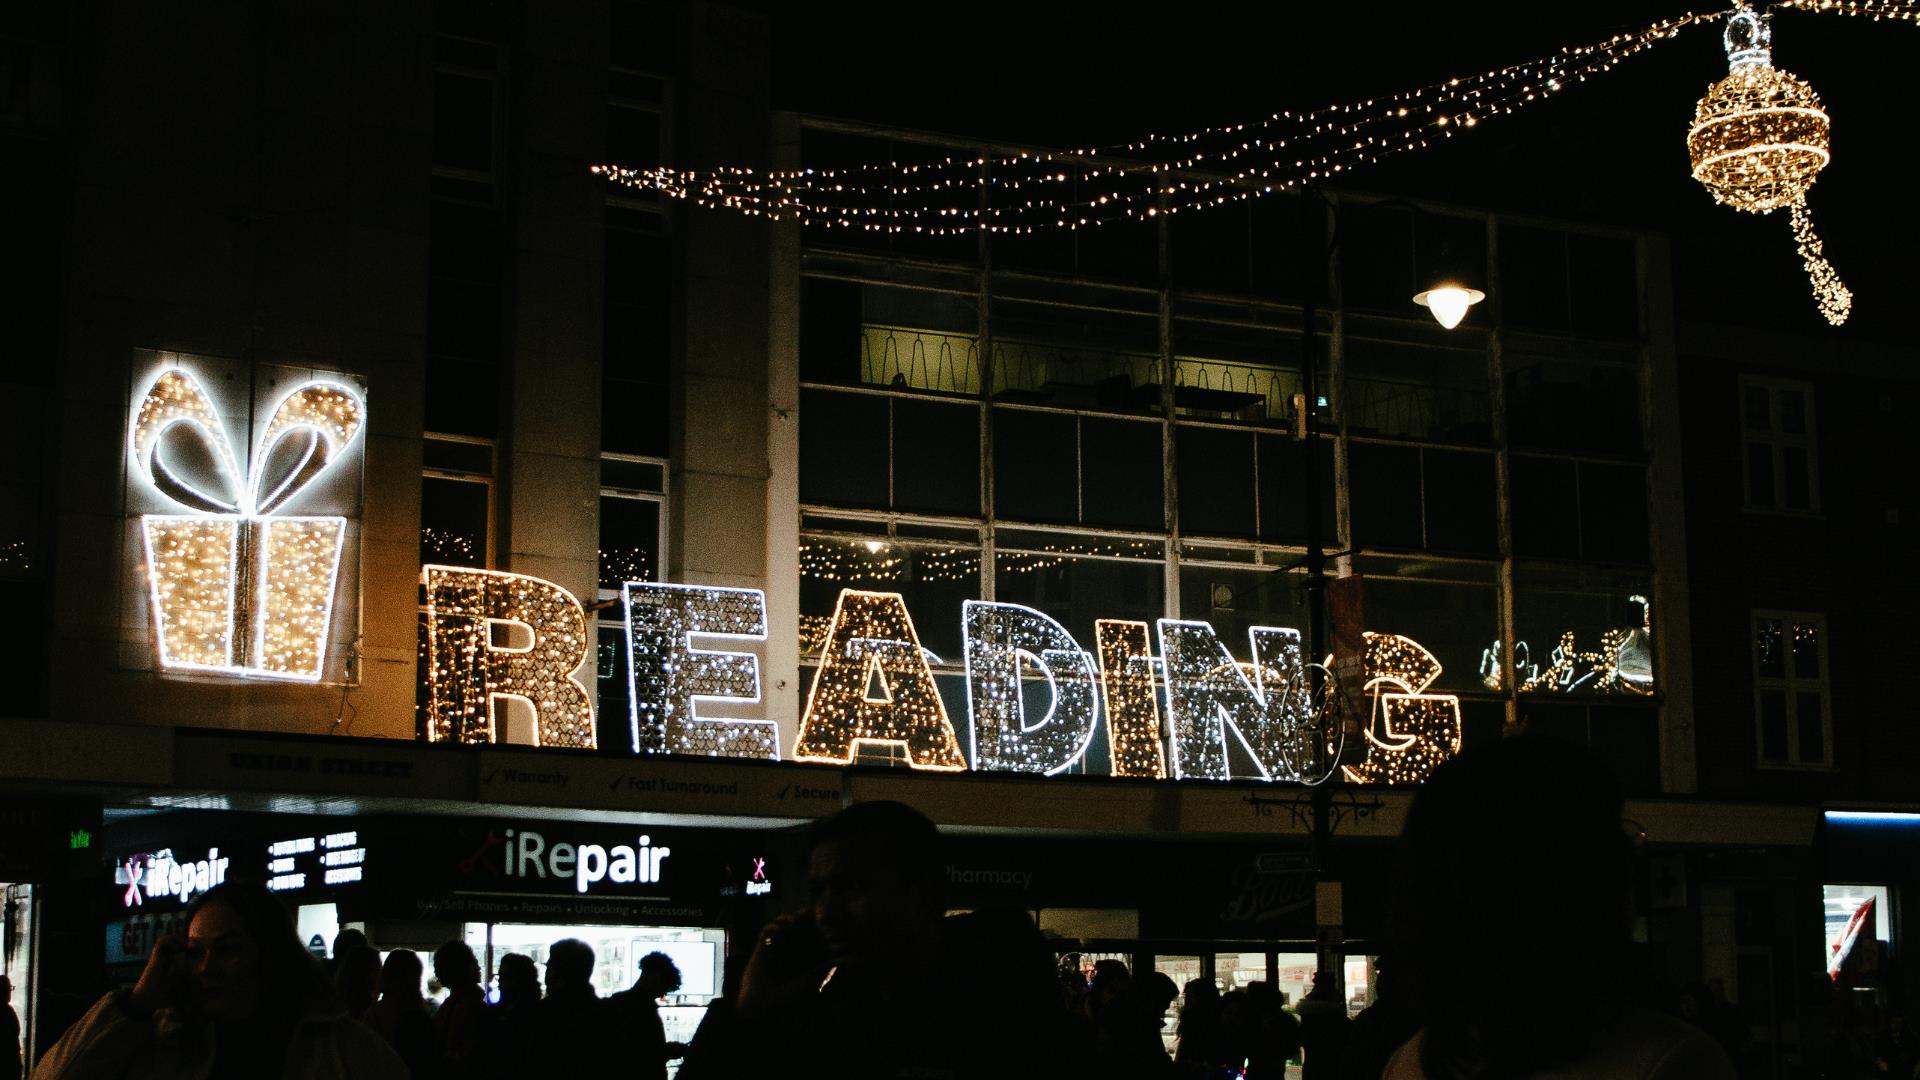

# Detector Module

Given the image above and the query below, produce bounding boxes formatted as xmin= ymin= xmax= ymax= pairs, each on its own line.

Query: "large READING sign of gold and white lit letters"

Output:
xmin=422 ymin=565 xmax=1461 ymax=780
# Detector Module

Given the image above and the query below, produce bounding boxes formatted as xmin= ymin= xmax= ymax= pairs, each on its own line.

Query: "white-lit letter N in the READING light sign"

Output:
xmin=1160 ymin=619 xmax=1325 ymax=782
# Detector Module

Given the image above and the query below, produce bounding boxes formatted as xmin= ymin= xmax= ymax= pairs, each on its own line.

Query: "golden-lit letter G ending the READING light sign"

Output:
xmin=1342 ymin=632 xmax=1459 ymax=784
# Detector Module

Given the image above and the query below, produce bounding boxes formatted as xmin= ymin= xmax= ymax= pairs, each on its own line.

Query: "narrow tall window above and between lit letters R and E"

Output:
xmin=593 ymin=454 xmax=666 ymax=753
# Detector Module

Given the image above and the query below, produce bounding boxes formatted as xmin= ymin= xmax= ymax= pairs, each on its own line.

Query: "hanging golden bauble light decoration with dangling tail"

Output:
xmin=1686 ymin=6 xmax=1853 ymax=327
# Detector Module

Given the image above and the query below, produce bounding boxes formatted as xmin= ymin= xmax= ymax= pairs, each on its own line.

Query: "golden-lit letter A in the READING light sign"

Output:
xmin=793 ymin=588 xmax=966 ymax=773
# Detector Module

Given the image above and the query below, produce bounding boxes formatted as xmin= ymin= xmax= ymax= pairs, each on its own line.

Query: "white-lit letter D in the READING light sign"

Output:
xmin=960 ymin=600 xmax=1098 ymax=776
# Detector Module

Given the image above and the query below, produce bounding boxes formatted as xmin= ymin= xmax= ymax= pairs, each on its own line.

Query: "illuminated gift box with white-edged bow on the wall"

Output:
xmin=127 ymin=367 xmax=367 ymax=682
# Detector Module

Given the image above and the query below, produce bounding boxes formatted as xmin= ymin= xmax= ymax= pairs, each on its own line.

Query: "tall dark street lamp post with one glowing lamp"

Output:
xmin=1300 ymin=184 xmax=1486 ymax=1009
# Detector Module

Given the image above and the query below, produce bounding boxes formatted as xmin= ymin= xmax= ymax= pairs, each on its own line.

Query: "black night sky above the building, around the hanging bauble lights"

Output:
xmin=774 ymin=0 xmax=1920 ymax=342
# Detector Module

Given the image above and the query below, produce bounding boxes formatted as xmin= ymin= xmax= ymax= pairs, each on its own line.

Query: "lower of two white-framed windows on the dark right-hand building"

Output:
xmin=1753 ymin=611 xmax=1834 ymax=767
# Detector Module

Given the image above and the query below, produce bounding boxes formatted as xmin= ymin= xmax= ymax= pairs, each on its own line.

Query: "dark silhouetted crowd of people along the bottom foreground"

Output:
xmin=33 ymin=736 xmax=1920 ymax=1080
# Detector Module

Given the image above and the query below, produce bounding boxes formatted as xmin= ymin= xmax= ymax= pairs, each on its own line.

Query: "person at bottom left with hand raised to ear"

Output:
xmin=33 ymin=882 xmax=407 ymax=1080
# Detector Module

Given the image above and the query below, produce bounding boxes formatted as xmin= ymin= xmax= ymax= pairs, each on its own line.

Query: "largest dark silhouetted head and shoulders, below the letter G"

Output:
xmin=1384 ymin=734 xmax=1734 ymax=1080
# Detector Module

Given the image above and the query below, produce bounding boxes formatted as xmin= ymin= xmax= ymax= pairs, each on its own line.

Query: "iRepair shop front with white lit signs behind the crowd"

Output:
xmin=93 ymin=811 xmax=793 ymax=1042
